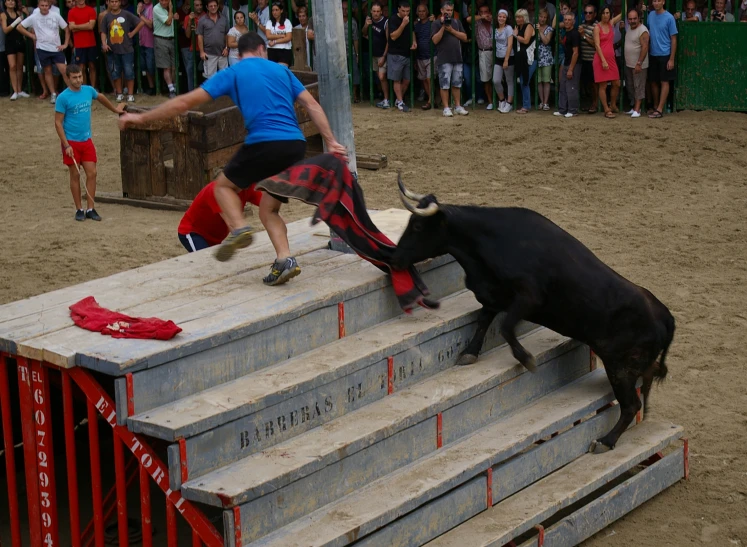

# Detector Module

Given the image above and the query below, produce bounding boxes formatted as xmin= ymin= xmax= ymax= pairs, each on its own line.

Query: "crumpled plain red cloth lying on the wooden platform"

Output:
xmin=70 ymin=296 xmax=182 ymax=340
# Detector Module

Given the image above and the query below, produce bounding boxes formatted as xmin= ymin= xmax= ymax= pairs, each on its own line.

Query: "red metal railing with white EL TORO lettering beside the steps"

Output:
xmin=0 ymin=353 xmax=223 ymax=547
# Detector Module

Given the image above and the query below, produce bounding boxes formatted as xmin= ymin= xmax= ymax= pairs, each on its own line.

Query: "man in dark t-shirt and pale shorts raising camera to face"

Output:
xmin=431 ymin=0 xmax=469 ymax=118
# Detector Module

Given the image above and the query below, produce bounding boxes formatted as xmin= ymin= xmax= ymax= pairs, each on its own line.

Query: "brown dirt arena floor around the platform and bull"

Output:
xmin=0 ymin=99 xmax=747 ymax=547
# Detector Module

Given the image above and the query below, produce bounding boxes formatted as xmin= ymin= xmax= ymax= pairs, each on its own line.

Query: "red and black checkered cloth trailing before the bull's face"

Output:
xmin=257 ymin=154 xmax=438 ymax=313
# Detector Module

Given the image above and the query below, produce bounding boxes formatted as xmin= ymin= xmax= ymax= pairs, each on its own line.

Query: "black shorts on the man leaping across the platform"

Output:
xmin=223 ymin=141 xmax=306 ymax=203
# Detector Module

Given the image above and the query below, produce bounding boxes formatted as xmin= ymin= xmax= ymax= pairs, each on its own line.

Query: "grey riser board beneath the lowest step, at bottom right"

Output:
xmin=522 ymin=448 xmax=685 ymax=547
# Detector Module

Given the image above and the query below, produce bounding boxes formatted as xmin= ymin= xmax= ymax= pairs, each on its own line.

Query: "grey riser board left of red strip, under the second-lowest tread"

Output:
xmin=355 ymin=476 xmax=487 ymax=547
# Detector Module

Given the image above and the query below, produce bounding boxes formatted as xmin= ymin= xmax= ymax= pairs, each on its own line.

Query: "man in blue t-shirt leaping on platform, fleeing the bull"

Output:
xmin=119 ymin=32 xmax=346 ymax=285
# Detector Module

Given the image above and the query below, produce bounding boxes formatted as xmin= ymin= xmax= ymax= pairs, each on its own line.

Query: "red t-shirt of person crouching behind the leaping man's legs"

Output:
xmin=178 ymin=182 xmax=262 ymax=245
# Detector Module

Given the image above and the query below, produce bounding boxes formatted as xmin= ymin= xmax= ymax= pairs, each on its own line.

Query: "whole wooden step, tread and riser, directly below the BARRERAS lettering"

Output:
xmin=182 ymin=329 xmax=589 ymax=538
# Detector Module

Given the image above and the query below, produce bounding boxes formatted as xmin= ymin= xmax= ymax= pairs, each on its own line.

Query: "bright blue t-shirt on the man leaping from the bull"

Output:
xmin=202 ymin=57 xmax=306 ymax=144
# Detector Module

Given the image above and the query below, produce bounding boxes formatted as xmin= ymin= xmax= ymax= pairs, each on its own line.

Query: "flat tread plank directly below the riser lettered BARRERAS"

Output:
xmin=183 ymin=329 xmax=588 ymax=505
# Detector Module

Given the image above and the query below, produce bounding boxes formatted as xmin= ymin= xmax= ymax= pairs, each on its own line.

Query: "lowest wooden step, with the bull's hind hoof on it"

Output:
xmin=428 ymin=420 xmax=685 ymax=547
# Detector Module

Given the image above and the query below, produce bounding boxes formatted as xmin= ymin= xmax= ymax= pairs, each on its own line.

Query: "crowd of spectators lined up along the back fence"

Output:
xmin=0 ymin=0 xmax=747 ymax=111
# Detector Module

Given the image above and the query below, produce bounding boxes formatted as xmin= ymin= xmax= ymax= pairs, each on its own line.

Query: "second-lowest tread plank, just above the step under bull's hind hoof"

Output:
xmin=231 ymin=364 xmax=624 ymax=547
